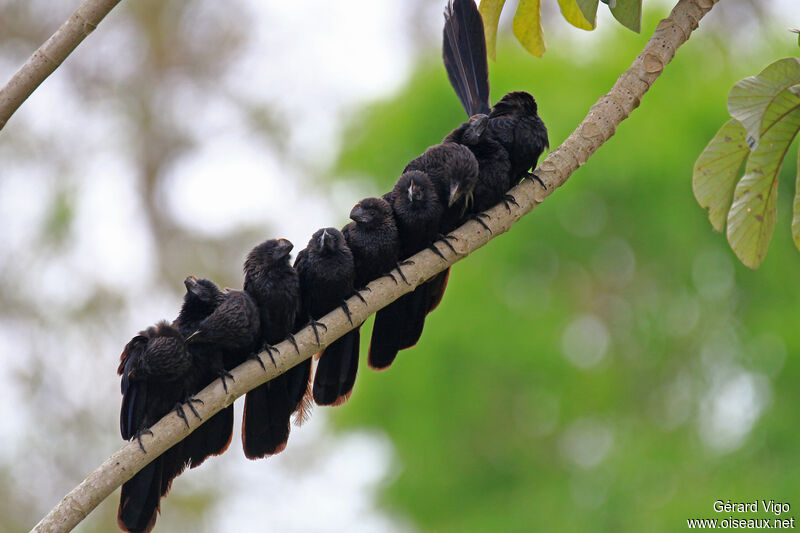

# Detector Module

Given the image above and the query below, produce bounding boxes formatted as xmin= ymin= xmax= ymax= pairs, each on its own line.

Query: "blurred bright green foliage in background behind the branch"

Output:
xmin=332 ymin=14 xmax=800 ymax=532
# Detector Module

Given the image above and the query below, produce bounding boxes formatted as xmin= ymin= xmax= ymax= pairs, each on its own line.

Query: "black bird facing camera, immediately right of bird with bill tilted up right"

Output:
xmin=294 ymin=228 xmax=359 ymax=405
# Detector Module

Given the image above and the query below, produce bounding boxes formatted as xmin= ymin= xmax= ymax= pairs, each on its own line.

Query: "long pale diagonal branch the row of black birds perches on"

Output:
xmin=33 ymin=0 xmax=718 ymax=532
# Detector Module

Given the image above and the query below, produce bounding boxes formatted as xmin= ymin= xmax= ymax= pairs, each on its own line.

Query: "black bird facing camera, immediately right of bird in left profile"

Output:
xmin=368 ymin=170 xmax=444 ymax=370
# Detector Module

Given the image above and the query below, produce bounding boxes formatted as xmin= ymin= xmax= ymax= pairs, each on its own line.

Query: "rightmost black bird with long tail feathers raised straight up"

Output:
xmin=442 ymin=0 xmax=549 ymax=206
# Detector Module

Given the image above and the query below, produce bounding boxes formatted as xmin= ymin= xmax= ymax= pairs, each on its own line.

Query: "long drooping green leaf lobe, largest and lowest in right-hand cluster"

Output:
xmin=728 ymin=102 xmax=800 ymax=268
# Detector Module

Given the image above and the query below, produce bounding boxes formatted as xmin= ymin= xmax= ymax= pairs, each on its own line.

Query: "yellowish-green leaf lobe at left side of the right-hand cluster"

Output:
xmin=692 ymin=119 xmax=750 ymax=232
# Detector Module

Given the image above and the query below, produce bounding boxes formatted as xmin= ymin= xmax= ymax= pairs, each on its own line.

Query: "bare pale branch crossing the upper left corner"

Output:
xmin=0 ymin=0 xmax=120 ymax=130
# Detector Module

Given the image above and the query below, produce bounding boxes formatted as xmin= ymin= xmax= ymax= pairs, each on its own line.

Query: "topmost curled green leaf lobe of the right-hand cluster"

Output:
xmin=728 ymin=57 xmax=800 ymax=149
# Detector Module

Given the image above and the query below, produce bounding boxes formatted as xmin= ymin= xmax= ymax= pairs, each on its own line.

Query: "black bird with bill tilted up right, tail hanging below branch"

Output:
xmin=242 ymin=239 xmax=311 ymax=459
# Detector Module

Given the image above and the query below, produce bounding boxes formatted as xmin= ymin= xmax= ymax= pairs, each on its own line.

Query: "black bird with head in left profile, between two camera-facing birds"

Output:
xmin=342 ymin=198 xmax=406 ymax=368
